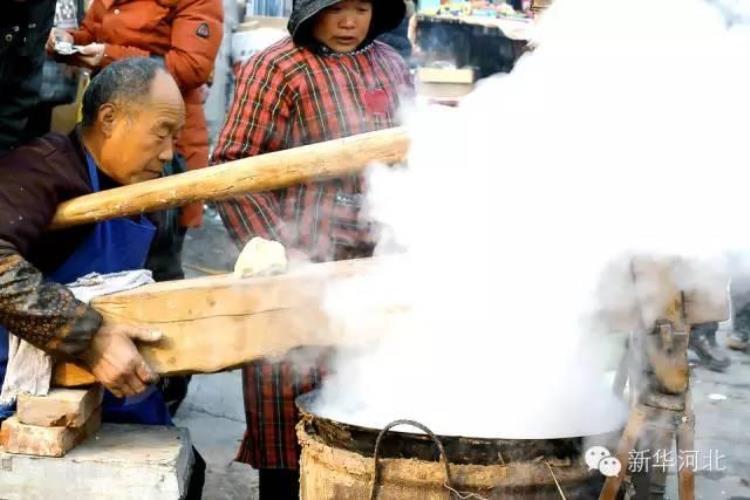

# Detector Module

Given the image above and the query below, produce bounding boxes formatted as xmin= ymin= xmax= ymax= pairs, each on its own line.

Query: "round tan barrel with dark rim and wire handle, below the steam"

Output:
xmin=297 ymin=396 xmax=611 ymax=500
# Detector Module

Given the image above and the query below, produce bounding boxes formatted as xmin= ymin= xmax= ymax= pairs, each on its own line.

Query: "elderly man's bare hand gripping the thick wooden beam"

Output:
xmin=81 ymin=325 xmax=161 ymax=398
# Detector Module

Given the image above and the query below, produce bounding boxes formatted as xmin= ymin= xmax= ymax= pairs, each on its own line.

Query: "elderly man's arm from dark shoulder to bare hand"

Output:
xmin=0 ymin=146 xmax=160 ymax=396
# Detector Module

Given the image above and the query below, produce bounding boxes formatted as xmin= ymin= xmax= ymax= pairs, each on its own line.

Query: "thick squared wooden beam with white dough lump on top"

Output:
xmin=54 ymin=258 xmax=406 ymax=387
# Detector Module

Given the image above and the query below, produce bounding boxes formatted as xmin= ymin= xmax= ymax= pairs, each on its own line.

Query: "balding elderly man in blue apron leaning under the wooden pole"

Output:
xmin=0 ymin=59 xmax=185 ymax=423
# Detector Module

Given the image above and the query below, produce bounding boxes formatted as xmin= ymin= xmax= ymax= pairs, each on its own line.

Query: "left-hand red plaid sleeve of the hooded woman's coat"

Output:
xmin=211 ymin=48 xmax=293 ymax=246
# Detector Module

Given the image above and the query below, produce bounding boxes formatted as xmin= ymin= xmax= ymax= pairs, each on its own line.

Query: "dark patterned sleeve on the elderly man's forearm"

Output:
xmin=0 ymin=240 xmax=102 ymax=357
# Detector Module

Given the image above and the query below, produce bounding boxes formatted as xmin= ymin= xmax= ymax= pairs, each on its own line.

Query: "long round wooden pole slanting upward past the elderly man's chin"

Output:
xmin=51 ymin=128 xmax=409 ymax=229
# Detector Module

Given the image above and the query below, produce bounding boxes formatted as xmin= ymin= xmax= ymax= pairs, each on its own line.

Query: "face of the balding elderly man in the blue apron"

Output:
xmin=99 ymin=71 xmax=185 ymax=184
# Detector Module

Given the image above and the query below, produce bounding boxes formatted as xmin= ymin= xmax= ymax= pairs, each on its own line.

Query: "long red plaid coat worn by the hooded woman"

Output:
xmin=213 ymin=38 xmax=413 ymax=469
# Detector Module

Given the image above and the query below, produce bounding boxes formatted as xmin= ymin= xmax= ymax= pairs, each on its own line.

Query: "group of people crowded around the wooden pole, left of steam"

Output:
xmin=0 ymin=0 xmax=413 ymax=500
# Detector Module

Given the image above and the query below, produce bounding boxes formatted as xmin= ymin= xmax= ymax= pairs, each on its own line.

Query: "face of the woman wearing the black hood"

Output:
xmin=313 ymin=0 xmax=372 ymax=52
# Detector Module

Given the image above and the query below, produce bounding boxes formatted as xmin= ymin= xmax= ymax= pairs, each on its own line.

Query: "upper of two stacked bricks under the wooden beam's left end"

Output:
xmin=16 ymin=385 xmax=103 ymax=427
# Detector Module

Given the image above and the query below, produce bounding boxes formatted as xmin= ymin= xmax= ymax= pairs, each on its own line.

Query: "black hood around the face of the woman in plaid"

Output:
xmin=287 ymin=0 xmax=406 ymax=45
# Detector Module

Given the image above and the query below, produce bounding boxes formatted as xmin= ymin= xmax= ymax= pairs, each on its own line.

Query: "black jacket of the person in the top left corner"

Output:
xmin=0 ymin=0 xmax=55 ymax=154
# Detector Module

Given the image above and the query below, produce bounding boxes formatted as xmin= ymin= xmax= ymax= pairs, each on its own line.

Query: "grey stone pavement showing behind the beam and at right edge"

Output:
xmin=177 ymin=207 xmax=750 ymax=500
